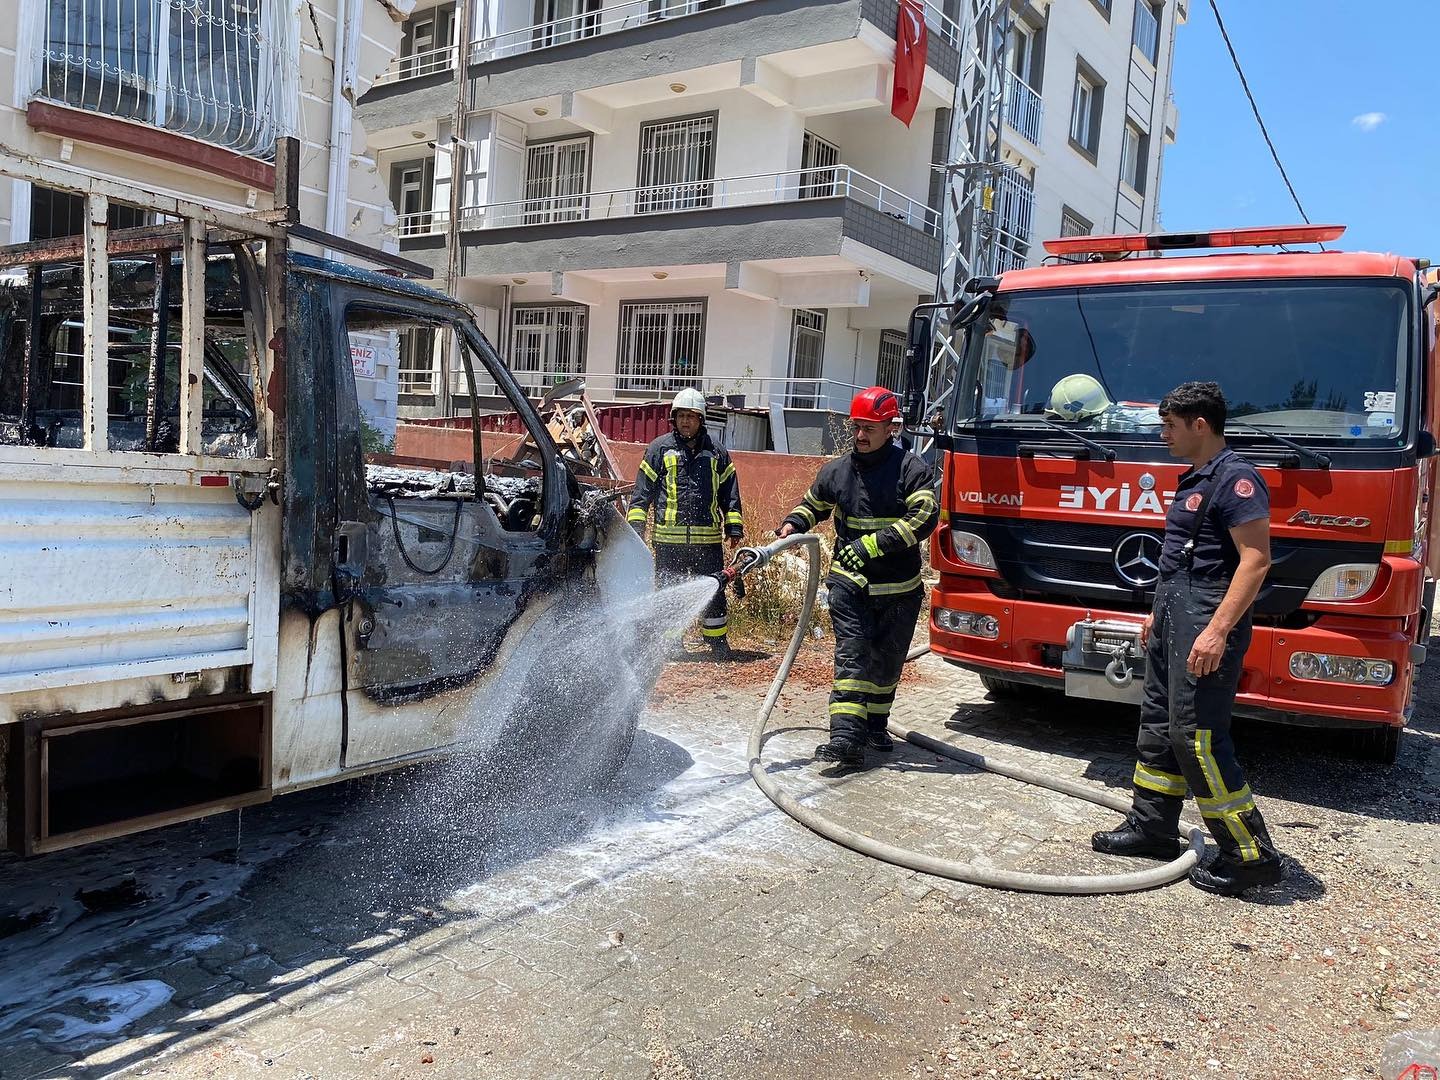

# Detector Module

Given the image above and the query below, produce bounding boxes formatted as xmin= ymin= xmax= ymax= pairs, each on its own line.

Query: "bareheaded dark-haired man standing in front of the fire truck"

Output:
xmin=1093 ymin=383 xmax=1282 ymax=896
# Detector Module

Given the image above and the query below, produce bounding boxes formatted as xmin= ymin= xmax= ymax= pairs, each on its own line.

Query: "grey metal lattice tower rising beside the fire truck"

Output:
xmin=924 ymin=0 xmax=1011 ymax=432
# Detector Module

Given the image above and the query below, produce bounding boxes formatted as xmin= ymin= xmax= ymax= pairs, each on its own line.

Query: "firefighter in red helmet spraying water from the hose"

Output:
xmin=776 ymin=386 xmax=940 ymax=768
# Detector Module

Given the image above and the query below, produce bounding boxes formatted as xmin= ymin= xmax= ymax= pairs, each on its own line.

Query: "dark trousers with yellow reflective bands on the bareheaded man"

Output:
xmin=1133 ymin=573 xmax=1274 ymax=861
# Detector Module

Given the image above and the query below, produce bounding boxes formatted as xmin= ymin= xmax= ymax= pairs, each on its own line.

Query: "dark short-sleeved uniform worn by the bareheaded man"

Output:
xmin=1132 ymin=448 xmax=1276 ymax=863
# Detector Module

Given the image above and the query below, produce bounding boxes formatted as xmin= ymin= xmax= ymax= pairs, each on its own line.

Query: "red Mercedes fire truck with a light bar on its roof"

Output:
xmin=912 ymin=226 xmax=1440 ymax=762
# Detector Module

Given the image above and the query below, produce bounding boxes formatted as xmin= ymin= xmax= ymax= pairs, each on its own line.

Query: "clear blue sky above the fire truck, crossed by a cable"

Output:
xmin=1161 ymin=0 xmax=1440 ymax=262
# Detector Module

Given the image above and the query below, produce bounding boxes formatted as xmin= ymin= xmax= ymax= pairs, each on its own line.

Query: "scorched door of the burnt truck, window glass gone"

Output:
xmin=277 ymin=262 xmax=570 ymax=768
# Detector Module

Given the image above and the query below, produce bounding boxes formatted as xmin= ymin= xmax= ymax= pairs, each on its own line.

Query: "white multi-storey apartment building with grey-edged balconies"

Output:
xmin=359 ymin=0 xmax=1185 ymax=416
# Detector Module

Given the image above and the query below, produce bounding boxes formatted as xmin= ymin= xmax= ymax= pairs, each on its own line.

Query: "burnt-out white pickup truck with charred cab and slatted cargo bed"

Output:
xmin=0 ymin=148 xmax=654 ymax=854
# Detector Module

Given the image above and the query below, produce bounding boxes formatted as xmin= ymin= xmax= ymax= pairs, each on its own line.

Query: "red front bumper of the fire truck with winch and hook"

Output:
xmin=930 ymin=580 xmax=1424 ymax=727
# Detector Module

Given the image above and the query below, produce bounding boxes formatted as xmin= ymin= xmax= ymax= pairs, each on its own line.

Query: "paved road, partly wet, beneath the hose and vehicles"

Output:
xmin=0 ymin=658 xmax=1440 ymax=1080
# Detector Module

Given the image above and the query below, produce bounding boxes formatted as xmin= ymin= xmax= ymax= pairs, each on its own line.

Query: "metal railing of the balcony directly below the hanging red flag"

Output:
xmin=399 ymin=166 xmax=940 ymax=236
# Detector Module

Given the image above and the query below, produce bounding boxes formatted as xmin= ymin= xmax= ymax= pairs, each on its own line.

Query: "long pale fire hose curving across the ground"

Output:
xmin=717 ymin=533 xmax=1205 ymax=896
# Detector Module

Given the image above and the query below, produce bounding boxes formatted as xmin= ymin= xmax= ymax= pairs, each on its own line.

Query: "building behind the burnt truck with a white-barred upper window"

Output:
xmin=0 ymin=0 xmax=413 ymax=435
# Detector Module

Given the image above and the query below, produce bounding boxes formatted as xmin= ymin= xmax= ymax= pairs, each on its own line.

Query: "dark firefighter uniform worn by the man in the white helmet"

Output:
xmin=628 ymin=428 xmax=744 ymax=649
